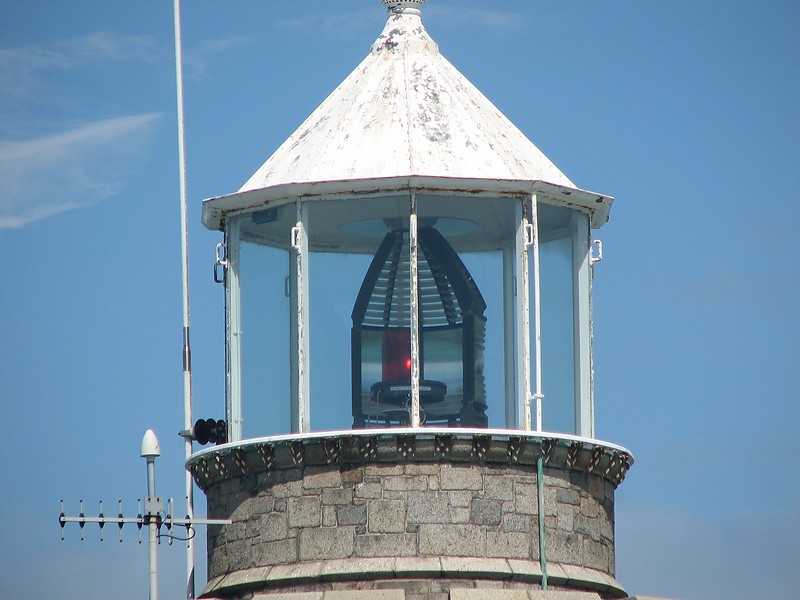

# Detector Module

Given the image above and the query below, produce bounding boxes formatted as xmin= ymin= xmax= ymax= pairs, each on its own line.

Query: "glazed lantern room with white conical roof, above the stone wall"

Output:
xmin=204 ymin=2 xmax=612 ymax=441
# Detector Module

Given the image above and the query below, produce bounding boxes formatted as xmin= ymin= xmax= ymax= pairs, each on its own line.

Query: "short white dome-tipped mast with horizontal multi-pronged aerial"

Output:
xmin=58 ymin=429 xmax=231 ymax=600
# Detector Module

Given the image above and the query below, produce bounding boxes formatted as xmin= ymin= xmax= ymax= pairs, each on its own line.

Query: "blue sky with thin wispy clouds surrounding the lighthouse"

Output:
xmin=0 ymin=0 xmax=800 ymax=600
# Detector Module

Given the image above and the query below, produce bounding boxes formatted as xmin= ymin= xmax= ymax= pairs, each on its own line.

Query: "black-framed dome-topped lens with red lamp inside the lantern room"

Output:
xmin=351 ymin=225 xmax=488 ymax=428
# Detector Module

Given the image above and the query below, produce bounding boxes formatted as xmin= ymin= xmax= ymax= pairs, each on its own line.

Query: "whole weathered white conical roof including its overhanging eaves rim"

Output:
xmin=203 ymin=0 xmax=613 ymax=229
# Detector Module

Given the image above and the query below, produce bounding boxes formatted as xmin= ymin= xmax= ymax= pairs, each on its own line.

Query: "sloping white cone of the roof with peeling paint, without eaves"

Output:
xmin=240 ymin=2 xmax=575 ymax=191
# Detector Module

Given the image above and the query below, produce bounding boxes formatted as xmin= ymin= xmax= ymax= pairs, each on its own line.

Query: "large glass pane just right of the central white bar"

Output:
xmin=417 ymin=194 xmax=519 ymax=428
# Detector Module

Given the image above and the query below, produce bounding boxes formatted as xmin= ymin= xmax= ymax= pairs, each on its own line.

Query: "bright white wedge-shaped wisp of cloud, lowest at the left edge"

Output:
xmin=0 ymin=113 xmax=160 ymax=229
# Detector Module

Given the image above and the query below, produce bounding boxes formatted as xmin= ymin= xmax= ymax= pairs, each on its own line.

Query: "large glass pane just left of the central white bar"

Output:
xmin=307 ymin=194 xmax=411 ymax=431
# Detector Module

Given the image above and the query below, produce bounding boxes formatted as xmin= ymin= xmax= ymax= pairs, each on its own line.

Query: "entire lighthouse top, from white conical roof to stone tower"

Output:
xmin=187 ymin=0 xmax=633 ymax=600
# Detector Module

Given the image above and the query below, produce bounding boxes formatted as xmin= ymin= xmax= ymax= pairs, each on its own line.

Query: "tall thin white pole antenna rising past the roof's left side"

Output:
xmin=173 ymin=0 xmax=195 ymax=600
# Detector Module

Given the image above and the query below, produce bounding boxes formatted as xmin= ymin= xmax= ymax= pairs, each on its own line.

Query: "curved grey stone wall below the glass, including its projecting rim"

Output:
xmin=187 ymin=429 xmax=633 ymax=598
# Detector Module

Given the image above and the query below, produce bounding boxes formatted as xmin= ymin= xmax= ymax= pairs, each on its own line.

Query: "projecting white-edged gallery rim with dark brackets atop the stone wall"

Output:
xmin=186 ymin=427 xmax=634 ymax=489
